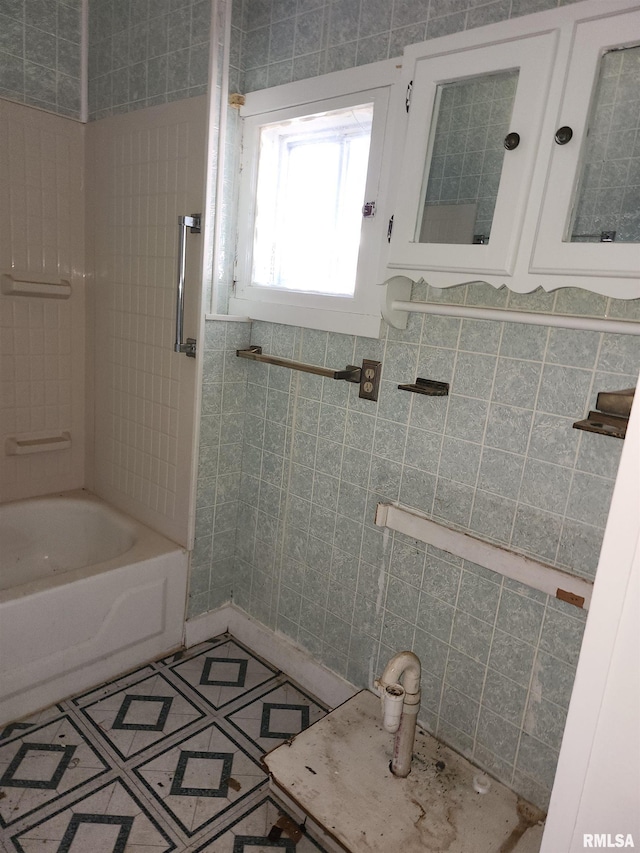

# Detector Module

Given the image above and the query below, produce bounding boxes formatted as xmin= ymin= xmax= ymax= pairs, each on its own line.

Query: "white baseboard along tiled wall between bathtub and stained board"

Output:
xmin=184 ymin=604 xmax=359 ymax=708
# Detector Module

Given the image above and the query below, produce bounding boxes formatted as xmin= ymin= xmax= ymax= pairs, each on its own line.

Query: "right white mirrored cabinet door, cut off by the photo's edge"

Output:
xmin=531 ymin=10 xmax=640 ymax=280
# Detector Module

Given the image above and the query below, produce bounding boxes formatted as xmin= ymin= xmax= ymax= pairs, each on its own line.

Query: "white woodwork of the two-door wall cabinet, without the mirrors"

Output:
xmin=385 ymin=0 xmax=640 ymax=299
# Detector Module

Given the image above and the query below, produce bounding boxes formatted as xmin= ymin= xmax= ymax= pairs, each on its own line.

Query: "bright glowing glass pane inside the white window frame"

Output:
xmin=252 ymin=104 xmax=373 ymax=296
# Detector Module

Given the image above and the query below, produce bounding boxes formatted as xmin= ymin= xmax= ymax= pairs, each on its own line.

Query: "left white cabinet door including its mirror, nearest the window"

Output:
xmin=389 ymin=32 xmax=557 ymax=280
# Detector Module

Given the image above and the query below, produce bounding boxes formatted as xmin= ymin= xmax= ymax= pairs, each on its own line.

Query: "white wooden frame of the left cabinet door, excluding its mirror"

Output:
xmin=389 ymin=32 xmax=557 ymax=274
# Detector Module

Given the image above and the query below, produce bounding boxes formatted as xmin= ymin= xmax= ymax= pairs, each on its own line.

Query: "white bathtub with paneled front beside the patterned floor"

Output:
xmin=0 ymin=490 xmax=187 ymax=724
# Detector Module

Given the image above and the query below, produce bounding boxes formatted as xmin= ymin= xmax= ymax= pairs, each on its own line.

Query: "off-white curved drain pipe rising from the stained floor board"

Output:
xmin=374 ymin=652 xmax=420 ymax=778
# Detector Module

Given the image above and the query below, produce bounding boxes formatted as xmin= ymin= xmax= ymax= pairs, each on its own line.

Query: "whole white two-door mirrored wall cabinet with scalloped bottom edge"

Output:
xmin=386 ymin=0 xmax=640 ymax=298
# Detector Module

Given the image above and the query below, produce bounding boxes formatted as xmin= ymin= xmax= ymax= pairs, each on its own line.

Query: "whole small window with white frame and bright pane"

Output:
xmin=230 ymin=62 xmax=397 ymax=337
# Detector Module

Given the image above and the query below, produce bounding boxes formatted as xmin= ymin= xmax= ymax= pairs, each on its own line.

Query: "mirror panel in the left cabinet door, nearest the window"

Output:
xmin=415 ymin=69 xmax=519 ymax=245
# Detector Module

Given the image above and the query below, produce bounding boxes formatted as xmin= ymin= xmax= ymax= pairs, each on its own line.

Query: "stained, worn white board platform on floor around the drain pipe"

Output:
xmin=263 ymin=690 xmax=542 ymax=853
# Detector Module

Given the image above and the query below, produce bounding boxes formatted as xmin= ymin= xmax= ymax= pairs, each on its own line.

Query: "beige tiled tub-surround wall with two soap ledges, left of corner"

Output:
xmin=0 ymin=100 xmax=85 ymax=502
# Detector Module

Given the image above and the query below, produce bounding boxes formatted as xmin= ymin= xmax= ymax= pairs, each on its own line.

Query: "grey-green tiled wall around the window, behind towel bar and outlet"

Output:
xmin=190 ymin=0 xmax=640 ymax=807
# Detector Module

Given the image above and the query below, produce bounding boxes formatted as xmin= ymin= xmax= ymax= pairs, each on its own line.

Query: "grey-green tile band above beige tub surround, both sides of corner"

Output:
xmin=0 ymin=0 xmax=212 ymax=119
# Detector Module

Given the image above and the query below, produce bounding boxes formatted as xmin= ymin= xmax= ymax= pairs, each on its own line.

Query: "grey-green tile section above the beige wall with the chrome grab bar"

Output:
xmin=89 ymin=0 xmax=211 ymax=119
